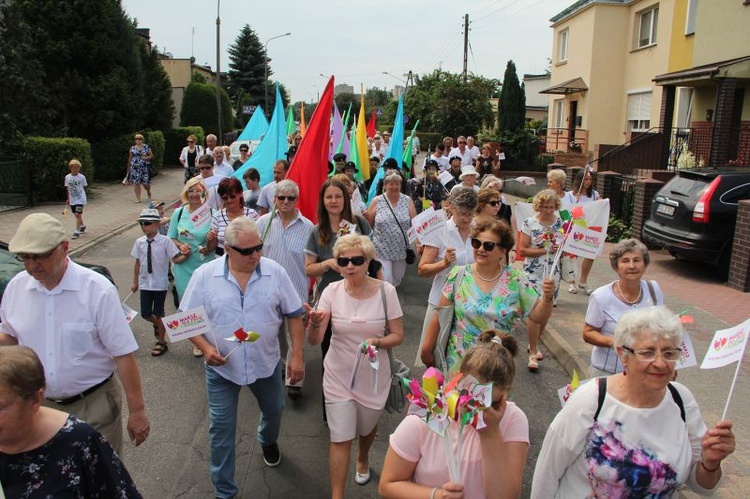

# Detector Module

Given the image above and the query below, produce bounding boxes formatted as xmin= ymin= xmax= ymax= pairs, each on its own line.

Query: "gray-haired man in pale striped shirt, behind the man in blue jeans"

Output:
xmin=258 ymin=179 xmax=313 ymax=400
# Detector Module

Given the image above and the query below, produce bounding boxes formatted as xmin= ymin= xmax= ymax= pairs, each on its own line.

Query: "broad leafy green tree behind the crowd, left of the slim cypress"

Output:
xmin=402 ymin=70 xmax=498 ymax=137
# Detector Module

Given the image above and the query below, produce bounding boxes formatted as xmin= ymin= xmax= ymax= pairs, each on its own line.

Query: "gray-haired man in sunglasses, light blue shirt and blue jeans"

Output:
xmin=180 ymin=217 xmax=309 ymax=498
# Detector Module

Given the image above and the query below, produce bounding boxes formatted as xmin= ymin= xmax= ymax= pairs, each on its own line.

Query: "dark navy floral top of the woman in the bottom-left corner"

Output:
xmin=0 ymin=416 xmax=142 ymax=499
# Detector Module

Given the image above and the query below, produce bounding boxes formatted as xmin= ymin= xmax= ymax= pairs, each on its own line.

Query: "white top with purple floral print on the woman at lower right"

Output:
xmin=531 ymin=380 xmax=706 ymax=499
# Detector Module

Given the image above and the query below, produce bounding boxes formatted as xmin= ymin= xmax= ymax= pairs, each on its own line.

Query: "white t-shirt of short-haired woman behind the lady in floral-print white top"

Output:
xmin=586 ymin=279 xmax=664 ymax=373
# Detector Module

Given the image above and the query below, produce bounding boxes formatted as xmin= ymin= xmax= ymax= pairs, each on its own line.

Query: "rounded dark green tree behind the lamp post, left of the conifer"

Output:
xmin=180 ymin=82 xmax=234 ymax=139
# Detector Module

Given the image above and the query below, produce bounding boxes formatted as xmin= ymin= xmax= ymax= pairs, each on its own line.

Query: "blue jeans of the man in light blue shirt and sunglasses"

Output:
xmin=205 ymin=363 xmax=284 ymax=498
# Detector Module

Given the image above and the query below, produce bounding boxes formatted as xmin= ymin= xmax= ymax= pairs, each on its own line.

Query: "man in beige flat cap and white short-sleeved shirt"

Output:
xmin=0 ymin=213 xmax=150 ymax=454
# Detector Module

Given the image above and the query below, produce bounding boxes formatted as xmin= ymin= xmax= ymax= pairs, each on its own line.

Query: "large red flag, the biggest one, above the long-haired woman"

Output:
xmin=286 ymin=76 xmax=333 ymax=223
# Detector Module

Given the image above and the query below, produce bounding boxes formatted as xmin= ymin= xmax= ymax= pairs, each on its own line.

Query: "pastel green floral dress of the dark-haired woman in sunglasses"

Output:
xmin=443 ymin=265 xmax=539 ymax=372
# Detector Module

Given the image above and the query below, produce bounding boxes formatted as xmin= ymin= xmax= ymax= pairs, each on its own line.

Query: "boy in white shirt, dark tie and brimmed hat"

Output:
xmin=130 ymin=208 xmax=188 ymax=357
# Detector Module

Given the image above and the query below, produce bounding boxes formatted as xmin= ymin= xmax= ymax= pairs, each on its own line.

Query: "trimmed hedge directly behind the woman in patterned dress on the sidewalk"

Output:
xmin=91 ymin=131 xmax=164 ymax=181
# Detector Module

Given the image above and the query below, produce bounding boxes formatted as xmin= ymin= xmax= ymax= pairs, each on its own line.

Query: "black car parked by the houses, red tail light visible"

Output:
xmin=642 ymin=167 xmax=750 ymax=280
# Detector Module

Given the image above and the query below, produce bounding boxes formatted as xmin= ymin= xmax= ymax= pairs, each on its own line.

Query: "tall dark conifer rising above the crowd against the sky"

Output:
xmin=227 ymin=24 xmax=273 ymax=111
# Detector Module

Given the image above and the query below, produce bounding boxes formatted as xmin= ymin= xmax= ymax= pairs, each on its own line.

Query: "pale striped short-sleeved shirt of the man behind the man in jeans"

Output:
xmin=258 ymin=210 xmax=313 ymax=302
